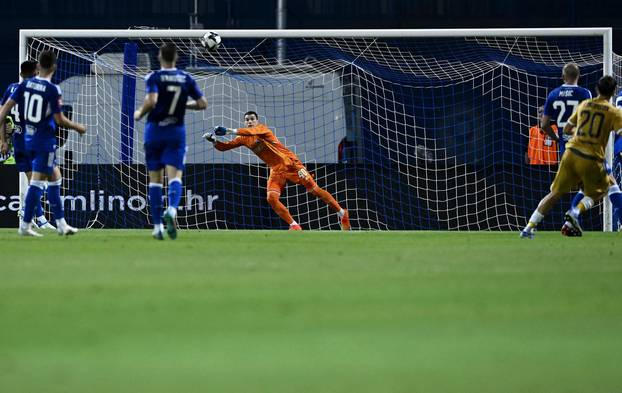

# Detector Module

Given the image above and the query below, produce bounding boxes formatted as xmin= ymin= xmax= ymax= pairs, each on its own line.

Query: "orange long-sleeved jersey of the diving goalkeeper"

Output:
xmin=215 ymin=124 xmax=302 ymax=169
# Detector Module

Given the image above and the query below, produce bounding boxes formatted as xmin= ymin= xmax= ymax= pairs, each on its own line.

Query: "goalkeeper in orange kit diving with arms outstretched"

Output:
xmin=203 ymin=111 xmax=350 ymax=231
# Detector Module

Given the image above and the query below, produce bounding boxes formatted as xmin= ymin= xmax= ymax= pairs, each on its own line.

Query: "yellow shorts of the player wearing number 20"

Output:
xmin=551 ymin=149 xmax=611 ymax=200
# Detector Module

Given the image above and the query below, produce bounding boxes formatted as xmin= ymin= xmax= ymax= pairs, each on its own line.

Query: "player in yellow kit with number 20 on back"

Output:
xmin=520 ymin=75 xmax=622 ymax=239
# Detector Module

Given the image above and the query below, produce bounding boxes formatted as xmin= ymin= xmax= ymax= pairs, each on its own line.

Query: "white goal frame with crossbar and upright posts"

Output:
xmin=19 ymin=27 xmax=613 ymax=231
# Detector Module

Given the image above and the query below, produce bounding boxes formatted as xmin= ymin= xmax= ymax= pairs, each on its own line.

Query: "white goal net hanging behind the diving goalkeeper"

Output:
xmin=22 ymin=29 xmax=611 ymax=230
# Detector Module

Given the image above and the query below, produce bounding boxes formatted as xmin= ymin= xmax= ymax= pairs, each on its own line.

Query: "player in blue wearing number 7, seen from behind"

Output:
xmin=134 ymin=44 xmax=207 ymax=240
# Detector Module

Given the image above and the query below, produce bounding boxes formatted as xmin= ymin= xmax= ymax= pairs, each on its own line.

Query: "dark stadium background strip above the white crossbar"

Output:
xmin=0 ymin=0 xmax=622 ymax=86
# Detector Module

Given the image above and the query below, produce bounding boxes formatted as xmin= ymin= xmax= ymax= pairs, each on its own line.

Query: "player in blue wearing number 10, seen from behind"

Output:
xmin=0 ymin=51 xmax=86 ymax=236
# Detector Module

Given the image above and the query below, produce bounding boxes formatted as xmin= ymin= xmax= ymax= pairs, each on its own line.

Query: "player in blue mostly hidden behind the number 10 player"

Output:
xmin=0 ymin=60 xmax=55 ymax=229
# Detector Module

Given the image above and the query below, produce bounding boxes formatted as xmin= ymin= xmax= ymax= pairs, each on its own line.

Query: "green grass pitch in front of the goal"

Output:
xmin=0 ymin=229 xmax=622 ymax=393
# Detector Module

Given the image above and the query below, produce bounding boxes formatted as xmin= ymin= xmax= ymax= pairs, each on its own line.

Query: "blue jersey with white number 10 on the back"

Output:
xmin=11 ymin=76 xmax=62 ymax=152
